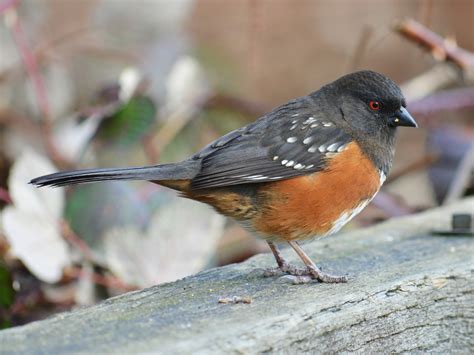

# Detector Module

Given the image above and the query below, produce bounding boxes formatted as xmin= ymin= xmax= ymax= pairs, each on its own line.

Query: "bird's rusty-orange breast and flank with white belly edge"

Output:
xmin=252 ymin=142 xmax=384 ymax=240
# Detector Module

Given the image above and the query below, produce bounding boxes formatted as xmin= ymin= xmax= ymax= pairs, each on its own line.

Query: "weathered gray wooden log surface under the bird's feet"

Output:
xmin=0 ymin=199 xmax=474 ymax=354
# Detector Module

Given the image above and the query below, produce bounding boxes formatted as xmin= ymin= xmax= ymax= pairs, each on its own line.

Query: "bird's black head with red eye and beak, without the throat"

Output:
xmin=327 ymin=70 xmax=417 ymax=139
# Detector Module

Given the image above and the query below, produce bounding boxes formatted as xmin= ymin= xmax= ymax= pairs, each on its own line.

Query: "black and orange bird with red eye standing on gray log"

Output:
xmin=30 ymin=70 xmax=417 ymax=283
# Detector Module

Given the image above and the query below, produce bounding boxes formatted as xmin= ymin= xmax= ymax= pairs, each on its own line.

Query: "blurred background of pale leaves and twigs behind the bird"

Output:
xmin=0 ymin=0 xmax=474 ymax=328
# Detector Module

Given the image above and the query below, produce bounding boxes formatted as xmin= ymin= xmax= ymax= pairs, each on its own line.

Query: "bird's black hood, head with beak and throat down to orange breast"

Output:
xmin=322 ymin=70 xmax=417 ymax=172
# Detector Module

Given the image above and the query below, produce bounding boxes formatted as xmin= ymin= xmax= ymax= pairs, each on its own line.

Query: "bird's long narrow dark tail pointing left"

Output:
xmin=30 ymin=160 xmax=199 ymax=191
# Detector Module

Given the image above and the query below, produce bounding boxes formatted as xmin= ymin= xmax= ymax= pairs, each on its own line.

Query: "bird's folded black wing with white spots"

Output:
xmin=191 ymin=98 xmax=351 ymax=189
